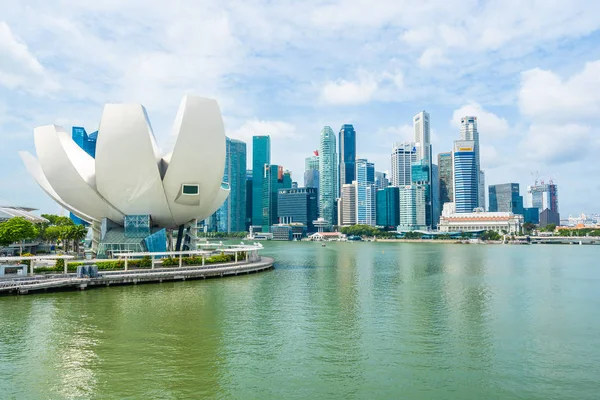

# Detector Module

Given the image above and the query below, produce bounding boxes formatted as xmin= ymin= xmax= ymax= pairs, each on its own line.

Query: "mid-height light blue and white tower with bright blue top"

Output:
xmin=356 ymin=158 xmax=377 ymax=226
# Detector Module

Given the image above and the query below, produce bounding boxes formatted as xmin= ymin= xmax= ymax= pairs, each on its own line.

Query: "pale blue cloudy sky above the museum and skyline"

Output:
xmin=0 ymin=0 xmax=600 ymax=218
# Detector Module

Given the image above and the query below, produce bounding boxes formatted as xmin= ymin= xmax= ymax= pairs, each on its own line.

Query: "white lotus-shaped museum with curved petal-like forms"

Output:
xmin=20 ymin=96 xmax=229 ymax=228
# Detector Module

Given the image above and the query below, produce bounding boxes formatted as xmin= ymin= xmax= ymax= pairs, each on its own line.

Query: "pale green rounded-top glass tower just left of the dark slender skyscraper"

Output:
xmin=319 ymin=126 xmax=338 ymax=225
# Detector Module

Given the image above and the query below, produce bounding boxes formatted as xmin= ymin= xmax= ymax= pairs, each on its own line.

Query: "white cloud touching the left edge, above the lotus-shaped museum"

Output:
xmin=0 ymin=21 xmax=57 ymax=92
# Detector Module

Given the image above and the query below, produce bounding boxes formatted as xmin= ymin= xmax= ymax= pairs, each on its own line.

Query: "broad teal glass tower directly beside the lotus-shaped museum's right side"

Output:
xmin=216 ymin=137 xmax=246 ymax=232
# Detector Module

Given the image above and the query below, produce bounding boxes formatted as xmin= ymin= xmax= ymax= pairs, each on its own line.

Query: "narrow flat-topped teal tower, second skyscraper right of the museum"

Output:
xmin=252 ymin=136 xmax=271 ymax=226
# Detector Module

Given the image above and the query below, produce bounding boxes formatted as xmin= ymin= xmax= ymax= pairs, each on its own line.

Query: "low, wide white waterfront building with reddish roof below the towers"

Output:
xmin=438 ymin=212 xmax=523 ymax=233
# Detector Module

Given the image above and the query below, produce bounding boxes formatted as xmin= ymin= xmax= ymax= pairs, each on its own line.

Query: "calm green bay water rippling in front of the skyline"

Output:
xmin=0 ymin=243 xmax=600 ymax=400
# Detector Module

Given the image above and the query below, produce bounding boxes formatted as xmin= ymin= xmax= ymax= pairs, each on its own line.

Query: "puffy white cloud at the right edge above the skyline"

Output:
xmin=519 ymin=60 xmax=600 ymax=121
